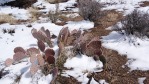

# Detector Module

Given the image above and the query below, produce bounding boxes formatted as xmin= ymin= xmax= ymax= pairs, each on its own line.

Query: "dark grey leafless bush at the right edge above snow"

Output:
xmin=114 ymin=10 xmax=149 ymax=38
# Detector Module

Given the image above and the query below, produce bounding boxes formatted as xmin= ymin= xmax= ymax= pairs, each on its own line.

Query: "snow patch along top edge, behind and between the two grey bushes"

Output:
xmin=99 ymin=0 xmax=147 ymax=15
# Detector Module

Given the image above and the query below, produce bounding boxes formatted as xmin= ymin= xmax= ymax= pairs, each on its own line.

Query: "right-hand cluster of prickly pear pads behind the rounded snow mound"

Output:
xmin=57 ymin=27 xmax=105 ymax=66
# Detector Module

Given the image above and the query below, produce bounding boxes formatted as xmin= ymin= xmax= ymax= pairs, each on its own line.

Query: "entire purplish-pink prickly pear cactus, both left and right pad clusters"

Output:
xmin=5 ymin=27 xmax=105 ymax=82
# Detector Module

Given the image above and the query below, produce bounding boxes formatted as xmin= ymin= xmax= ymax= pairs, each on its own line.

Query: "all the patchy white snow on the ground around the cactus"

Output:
xmin=0 ymin=0 xmax=149 ymax=84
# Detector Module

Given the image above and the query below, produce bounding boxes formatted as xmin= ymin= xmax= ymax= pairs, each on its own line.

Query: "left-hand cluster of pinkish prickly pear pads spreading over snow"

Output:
xmin=5 ymin=27 xmax=58 ymax=82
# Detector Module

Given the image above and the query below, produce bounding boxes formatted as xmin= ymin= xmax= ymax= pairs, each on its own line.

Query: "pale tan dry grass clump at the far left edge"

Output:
xmin=0 ymin=13 xmax=17 ymax=24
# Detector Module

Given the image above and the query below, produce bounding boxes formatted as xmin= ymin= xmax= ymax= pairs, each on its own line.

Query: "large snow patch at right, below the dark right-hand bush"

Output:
xmin=102 ymin=31 xmax=149 ymax=70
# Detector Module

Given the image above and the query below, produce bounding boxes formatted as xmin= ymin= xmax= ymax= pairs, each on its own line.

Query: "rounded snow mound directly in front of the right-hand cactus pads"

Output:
xmin=63 ymin=55 xmax=103 ymax=84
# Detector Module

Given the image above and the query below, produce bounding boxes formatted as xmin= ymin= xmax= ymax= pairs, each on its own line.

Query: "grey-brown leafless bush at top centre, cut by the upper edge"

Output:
xmin=78 ymin=0 xmax=102 ymax=21
